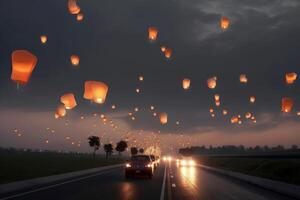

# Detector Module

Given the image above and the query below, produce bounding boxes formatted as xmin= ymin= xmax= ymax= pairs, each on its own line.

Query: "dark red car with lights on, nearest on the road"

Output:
xmin=125 ymin=155 xmax=154 ymax=179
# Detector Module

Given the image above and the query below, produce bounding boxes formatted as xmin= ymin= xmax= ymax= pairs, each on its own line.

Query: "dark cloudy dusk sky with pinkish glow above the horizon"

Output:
xmin=0 ymin=0 xmax=300 ymax=151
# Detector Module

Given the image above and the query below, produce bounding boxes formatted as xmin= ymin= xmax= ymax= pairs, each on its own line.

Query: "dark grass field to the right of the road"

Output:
xmin=198 ymin=156 xmax=300 ymax=185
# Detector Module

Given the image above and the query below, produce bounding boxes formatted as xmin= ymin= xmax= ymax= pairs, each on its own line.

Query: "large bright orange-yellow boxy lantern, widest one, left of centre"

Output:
xmin=83 ymin=81 xmax=108 ymax=104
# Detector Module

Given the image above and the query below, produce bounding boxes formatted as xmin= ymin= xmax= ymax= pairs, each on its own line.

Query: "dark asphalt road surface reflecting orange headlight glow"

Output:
xmin=0 ymin=162 xmax=296 ymax=200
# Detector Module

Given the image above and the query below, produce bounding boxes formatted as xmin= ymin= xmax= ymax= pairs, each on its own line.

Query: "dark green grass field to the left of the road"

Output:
xmin=0 ymin=150 xmax=125 ymax=184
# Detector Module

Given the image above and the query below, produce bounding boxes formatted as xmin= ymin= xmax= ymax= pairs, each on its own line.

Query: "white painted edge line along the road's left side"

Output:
xmin=0 ymin=168 xmax=117 ymax=200
